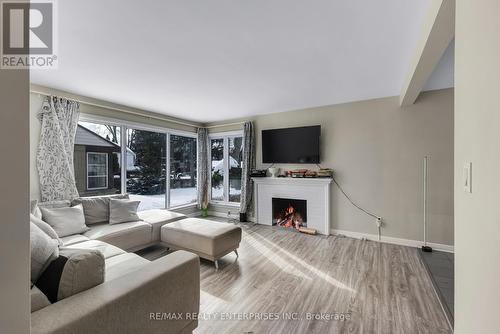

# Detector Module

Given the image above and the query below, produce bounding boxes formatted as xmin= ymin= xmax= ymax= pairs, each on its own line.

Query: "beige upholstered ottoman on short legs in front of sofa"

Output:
xmin=161 ymin=218 xmax=241 ymax=269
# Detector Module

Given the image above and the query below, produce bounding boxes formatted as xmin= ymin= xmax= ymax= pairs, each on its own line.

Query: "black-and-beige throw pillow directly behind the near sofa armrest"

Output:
xmin=35 ymin=248 xmax=105 ymax=303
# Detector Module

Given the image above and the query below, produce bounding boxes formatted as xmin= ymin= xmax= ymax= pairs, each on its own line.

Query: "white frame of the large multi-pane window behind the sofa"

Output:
xmin=79 ymin=113 xmax=199 ymax=209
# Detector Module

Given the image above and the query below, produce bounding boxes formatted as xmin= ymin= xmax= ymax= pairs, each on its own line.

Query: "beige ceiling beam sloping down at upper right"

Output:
xmin=399 ymin=0 xmax=455 ymax=106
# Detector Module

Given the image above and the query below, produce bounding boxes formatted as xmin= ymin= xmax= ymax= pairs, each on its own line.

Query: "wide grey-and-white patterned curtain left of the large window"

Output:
xmin=36 ymin=96 xmax=80 ymax=201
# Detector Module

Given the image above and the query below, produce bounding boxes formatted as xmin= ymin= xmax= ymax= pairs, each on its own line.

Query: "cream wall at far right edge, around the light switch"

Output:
xmin=455 ymin=0 xmax=500 ymax=334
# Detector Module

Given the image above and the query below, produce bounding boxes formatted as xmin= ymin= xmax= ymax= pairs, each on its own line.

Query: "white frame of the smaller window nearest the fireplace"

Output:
xmin=207 ymin=130 xmax=244 ymax=207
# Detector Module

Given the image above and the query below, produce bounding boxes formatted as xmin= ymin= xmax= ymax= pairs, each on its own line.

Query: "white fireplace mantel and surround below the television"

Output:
xmin=252 ymin=177 xmax=332 ymax=235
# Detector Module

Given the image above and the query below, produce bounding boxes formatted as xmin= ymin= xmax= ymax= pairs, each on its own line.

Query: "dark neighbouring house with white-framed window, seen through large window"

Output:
xmin=73 ymin=125 xmax=123 ymax=196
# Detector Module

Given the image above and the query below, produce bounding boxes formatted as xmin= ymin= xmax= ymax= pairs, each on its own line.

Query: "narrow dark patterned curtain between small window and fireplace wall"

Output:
xmin=240 ymin=122 xmax=255 ymax=213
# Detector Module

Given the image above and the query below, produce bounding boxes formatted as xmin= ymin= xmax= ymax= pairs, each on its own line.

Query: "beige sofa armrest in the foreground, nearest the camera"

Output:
xmin=31 ymin=251 xmax=200 ymax=334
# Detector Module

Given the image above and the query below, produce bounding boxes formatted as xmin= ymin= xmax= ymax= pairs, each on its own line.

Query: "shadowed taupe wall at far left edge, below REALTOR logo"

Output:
xmin=0 ymin=70 xmax=30 ymax=334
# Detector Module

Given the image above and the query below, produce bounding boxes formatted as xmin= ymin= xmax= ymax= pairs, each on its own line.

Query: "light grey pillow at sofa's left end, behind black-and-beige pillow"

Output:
xmin=30 ymin=222 xmax=59 ymax=282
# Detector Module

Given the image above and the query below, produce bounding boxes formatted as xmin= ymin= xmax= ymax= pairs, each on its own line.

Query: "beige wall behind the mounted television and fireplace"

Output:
xmin=209 ymin=89 xmax=453 ymax=245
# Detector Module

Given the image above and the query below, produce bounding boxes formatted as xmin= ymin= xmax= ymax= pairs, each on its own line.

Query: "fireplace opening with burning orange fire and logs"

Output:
xmin=273 ymin=198 xmax=307 ymax=229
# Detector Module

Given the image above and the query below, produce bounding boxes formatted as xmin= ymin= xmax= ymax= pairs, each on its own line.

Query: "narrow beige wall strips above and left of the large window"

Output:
xmin=30 ymin=85 xmax=201 ymax=199
